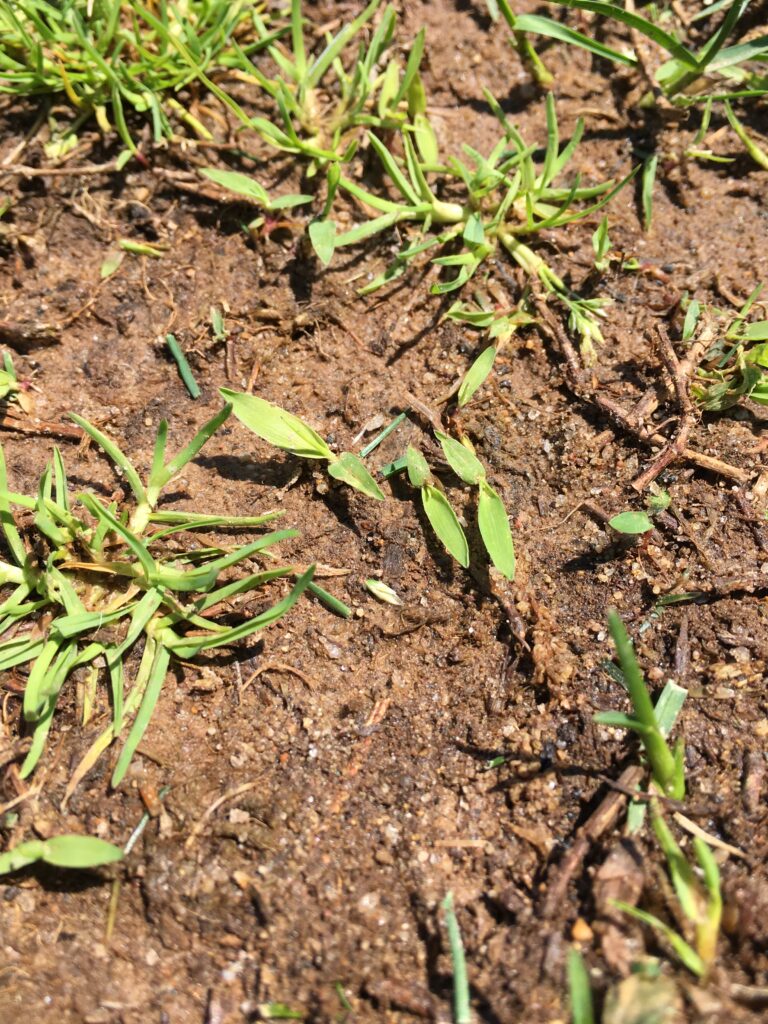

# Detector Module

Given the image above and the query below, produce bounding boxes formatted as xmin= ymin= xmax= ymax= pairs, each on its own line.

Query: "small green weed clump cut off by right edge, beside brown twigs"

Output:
xmin=683 ymin=285 xmax=768 ymax=413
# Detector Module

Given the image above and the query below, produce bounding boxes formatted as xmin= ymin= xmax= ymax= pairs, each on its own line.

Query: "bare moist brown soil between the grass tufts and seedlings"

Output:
xmin=0 ymin=0 xmax=768 ymax=1024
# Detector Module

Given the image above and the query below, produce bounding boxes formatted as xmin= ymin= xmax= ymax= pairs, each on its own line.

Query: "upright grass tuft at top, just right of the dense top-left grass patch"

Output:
xmin=234 ymin=0 xmax=424 ymax=169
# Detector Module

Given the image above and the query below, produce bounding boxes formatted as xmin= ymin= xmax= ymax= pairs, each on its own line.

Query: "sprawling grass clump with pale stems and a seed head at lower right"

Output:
xmin=318 ymin=92 xmax=634 ymax=362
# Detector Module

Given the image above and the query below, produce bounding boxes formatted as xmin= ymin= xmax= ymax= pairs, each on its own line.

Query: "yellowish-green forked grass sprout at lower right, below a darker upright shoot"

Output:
xmin=613 ymin=800 xmax=723 ymax=978
